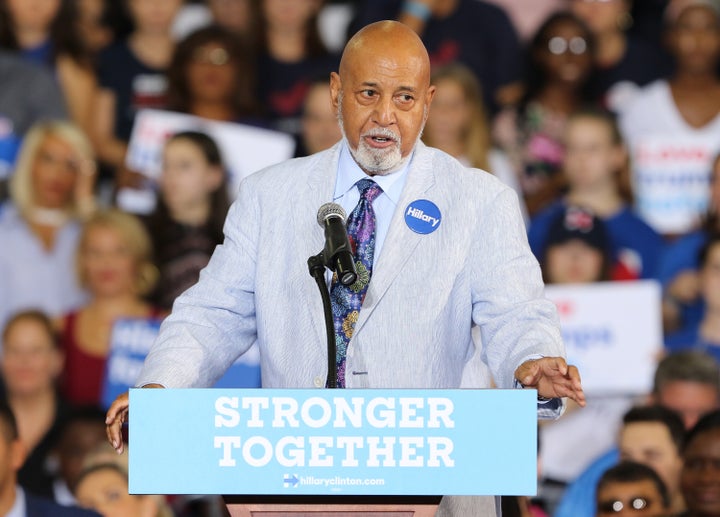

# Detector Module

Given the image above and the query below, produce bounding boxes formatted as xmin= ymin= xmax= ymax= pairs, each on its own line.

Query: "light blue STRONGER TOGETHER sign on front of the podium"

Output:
xmin=129 ymin=389 xmax=537 ymax=495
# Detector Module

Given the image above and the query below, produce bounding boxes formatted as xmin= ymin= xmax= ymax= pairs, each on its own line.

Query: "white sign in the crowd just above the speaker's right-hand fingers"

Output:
xmin=545 ymin=280 xmax=662 ymax=395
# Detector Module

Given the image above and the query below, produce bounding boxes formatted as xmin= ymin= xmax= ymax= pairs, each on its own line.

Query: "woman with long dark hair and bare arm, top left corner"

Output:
xmin=0 ymin=0 xmax=96 ymax=132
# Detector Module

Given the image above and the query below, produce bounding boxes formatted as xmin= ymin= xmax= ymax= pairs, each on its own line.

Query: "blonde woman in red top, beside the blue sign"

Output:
xmin=60 ymin=210 xmax=162 ymax=405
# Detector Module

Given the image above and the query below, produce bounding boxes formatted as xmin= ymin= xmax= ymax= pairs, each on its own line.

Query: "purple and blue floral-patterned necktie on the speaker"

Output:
xmin=330 ymin=179 xmax=382 ymax=388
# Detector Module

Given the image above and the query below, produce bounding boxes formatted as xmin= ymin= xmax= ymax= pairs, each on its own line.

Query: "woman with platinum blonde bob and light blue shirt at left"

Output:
xmin=0 ymin=121 xmax=95 ymax=327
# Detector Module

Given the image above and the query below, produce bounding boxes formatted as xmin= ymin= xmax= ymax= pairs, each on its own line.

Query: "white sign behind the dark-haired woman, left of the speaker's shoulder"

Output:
xmin=126 ymin=109 xmax=295 ymax=197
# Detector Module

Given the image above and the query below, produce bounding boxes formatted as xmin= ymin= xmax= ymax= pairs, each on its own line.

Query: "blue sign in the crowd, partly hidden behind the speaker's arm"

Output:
xmin=102 ymin=318 xmax=260 ymax=408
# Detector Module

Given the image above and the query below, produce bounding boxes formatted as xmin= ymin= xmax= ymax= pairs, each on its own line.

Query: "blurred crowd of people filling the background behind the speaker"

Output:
xmin=0 ymin=0 xmax=720 ymax=517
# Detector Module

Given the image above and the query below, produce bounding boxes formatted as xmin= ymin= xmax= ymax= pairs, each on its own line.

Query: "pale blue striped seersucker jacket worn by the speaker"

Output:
xmin=138 ymin=139 xmax=564 ymax=517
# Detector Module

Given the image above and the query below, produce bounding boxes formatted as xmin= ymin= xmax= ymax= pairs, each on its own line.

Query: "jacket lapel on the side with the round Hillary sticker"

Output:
xmin=355 ymin=142 xmax=435 ymax=334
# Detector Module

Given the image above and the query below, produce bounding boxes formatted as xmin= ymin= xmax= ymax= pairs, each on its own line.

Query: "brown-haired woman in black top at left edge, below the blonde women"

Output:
xmin=0 ymin=310 xmax=68 ymax=499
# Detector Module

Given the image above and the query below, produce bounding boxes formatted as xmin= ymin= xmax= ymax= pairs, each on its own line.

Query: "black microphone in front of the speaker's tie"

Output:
xmin=317 ymin=203 xmax=357 ymax=285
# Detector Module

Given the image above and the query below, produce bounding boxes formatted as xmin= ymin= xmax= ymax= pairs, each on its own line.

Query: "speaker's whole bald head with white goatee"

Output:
xmin=330 ymin=21 xmax=435 ymax=175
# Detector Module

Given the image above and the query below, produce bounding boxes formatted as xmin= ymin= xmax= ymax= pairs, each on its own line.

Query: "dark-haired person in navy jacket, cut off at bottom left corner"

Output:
xmin=0 ymin=399 xmax=98 ymax=517
